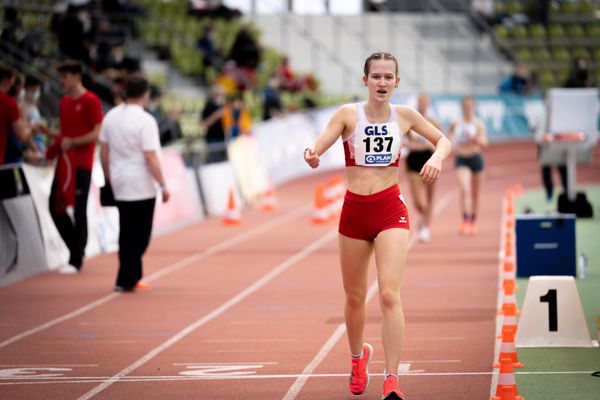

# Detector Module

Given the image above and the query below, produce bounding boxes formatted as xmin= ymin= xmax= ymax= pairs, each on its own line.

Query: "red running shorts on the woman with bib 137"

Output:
xmin=339 ymin=185 xmax=410 ymax=240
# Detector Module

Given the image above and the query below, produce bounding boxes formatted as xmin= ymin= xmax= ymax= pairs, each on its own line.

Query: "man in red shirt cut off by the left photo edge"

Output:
xmin=0 ymin=66 xmax=29 ymax=199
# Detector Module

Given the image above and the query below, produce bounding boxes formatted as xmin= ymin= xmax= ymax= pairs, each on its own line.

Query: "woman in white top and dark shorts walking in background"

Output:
xmin=448 ymin=96 xmax=488 ymax=236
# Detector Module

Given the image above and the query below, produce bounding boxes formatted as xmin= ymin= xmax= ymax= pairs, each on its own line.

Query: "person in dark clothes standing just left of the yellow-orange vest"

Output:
xmin=200 ymin=85 xmax=227 ymax=164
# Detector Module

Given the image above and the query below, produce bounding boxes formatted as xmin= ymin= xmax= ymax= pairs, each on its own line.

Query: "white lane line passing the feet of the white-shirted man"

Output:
xmin=0 ymin=206 xmax=311 ymax=349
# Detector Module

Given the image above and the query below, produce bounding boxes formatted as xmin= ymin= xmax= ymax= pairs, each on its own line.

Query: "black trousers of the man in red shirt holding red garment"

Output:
xmin=49 ymin=168 xmax=92 ymax=269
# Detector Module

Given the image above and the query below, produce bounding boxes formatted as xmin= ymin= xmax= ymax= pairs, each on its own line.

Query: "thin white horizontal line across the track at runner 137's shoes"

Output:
xmin=0 ymin=371 xmax=593 ymax=386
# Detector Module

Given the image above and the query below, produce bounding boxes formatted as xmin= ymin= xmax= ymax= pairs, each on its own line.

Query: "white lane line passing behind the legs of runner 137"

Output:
xmin=282 ymin=191 xmax=456 ymax=400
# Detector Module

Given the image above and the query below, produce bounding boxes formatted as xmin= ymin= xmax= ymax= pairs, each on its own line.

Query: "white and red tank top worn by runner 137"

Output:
xmin=344 ymin=103 xmax=401 ymax=167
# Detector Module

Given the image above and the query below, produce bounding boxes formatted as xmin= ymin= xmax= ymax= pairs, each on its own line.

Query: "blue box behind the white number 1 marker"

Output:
xmin=516 ymin=214 xmax=577 ymax=278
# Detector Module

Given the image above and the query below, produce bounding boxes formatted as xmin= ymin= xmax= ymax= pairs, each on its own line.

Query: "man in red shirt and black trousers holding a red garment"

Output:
xmin=39 ymin=61 xmax=103 ymax=274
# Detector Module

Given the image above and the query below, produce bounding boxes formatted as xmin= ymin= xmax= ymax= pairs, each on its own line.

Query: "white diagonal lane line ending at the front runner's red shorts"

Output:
xmin=78 ymin=230 xmax=337 ymax=400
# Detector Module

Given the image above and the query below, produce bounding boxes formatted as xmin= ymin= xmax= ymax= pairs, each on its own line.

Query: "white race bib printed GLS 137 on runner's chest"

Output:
xmin=354 ymin=122 xmax=400 ymax=167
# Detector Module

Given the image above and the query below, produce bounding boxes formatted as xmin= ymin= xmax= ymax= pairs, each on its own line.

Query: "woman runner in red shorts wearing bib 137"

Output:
xmin=304 ymin=52 xmax=451 ymax=400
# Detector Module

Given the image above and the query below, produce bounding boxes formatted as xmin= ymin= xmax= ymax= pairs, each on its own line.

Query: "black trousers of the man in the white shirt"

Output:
xmin=116 ymin=198 xmax=156 ymax=289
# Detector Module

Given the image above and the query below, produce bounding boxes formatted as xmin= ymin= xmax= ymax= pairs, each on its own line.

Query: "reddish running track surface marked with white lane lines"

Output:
xmin=0 ymin=143 xmax=600 ymax=400
